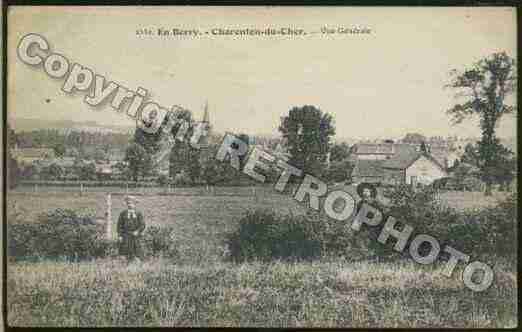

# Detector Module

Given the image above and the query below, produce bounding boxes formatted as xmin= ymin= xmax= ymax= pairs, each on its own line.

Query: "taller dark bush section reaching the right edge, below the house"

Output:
xmin=371 ymin=187 xmax=518 ymax=261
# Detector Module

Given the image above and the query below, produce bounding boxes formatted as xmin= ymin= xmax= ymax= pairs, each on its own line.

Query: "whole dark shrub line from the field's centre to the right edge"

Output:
xmin=226 ymin=186 xmax=517 ymax=262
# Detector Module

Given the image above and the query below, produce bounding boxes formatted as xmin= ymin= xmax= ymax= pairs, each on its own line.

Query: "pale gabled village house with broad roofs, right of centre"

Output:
xmin=352 ymin=143 xmax=448 ymax=185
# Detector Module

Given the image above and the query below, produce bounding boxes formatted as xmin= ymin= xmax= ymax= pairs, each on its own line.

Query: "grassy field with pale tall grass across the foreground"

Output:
xmin=7 ymin=188 xmax=517 ymax=327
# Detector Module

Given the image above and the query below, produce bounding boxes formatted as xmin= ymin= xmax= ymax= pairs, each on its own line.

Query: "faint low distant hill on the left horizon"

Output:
xmin=9 ymin=118 xmax=134 ymax=133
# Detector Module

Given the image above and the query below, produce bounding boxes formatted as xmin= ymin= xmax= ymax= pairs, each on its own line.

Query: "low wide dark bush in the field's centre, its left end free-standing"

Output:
xmin=226 ymin=209 xmax=368 ymax=261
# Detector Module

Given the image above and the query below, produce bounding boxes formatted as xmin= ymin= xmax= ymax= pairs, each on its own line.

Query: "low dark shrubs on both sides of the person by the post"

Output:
xmin=8 ymin=209 xmax=178 ymax=261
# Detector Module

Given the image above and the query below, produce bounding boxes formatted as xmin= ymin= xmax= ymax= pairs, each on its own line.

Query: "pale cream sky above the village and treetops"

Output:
xmin=8 ymin=6 xmax=517 ymax=138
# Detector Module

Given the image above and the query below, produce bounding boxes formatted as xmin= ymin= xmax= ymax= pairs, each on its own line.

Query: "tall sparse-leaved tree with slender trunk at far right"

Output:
xmin=446 ymin=52 xmax=517 ymax=195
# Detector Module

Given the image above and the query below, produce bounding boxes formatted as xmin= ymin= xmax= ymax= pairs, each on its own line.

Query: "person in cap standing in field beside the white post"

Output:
xmin=117 ymin=196 xmax=145 ymax=261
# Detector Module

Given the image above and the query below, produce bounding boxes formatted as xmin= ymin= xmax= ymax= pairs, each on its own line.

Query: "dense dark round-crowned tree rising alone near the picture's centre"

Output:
xmin=279 ymin=105 xmax=335 ymax=176
